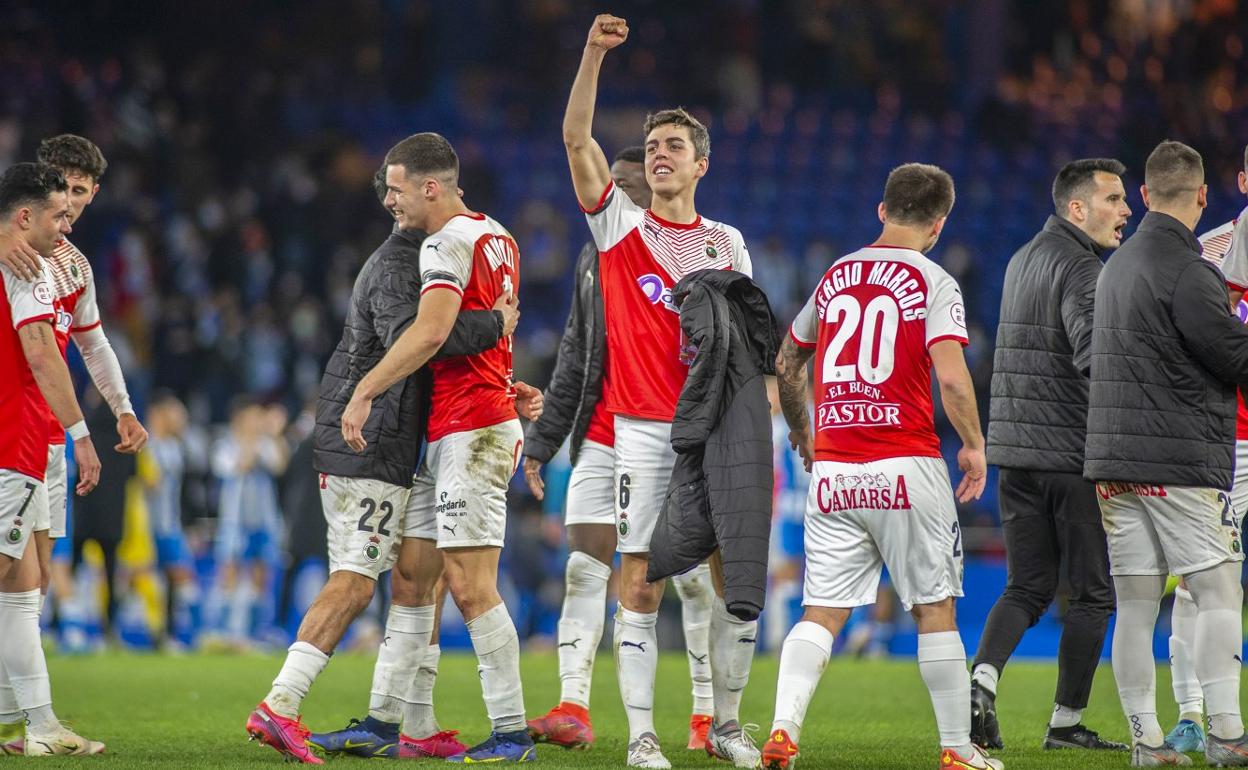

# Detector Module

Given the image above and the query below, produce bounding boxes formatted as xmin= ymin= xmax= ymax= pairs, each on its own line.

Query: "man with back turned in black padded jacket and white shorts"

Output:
xmin=1083 ymin=141 xmax=1248 ymax=768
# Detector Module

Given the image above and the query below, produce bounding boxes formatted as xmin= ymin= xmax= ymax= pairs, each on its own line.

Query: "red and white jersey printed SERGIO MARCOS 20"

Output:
xmin=789 ymin=246 xmax=967 ymax=463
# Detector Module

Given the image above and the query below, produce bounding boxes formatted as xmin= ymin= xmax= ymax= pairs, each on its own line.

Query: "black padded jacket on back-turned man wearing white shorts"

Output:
xmin=1083 ymin=212 xmax=1248 ymax=489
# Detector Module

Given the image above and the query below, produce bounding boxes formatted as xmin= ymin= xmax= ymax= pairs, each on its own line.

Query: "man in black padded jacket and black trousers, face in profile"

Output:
xmin=971 ymin=158 xmax=1131 ymax=750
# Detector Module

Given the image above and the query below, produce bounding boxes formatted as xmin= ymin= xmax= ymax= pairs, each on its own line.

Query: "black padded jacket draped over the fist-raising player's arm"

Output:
xmin=645 ymin=270 xmax=780 ymax=620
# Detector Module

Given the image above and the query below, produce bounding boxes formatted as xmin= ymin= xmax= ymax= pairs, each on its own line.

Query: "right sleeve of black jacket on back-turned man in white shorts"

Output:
xmin=1172 ymin=260 xmax=1248 ymax=384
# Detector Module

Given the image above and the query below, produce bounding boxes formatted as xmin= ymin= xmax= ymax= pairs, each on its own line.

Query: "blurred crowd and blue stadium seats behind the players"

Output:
xmin=7 ymin=0 xmax=1248 ymax=639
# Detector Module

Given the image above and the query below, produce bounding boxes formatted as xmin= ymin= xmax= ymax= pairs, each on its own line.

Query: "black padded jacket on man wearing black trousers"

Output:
xmin=988 ymin=216 xmax=1102 ymax=473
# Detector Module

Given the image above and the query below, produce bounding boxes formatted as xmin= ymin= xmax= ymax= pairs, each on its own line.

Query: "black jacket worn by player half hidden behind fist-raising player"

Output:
xmin=524 ymin=242 xmax=607 ymax=464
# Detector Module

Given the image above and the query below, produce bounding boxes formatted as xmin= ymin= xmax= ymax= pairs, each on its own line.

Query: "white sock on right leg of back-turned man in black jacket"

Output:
xmin=1186 ymin=562 xmax=1244 ymax=740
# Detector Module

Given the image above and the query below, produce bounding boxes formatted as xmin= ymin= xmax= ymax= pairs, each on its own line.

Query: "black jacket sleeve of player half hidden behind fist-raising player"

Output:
xmin=524 ymin=243 xmax=597 ymax=463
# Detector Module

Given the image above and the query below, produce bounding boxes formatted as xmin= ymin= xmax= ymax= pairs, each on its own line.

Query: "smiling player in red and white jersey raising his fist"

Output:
xmin=563 ymin=14 xmax=759 ymax=768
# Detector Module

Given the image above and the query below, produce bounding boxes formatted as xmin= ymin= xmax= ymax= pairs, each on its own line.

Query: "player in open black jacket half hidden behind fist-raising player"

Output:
xmin=524 ymin=147 xmax=714 ymax=750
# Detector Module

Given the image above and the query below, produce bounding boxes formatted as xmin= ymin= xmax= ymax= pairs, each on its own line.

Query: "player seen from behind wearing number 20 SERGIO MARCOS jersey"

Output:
xmin=763 ymin=163 xmax=1002 ymax=770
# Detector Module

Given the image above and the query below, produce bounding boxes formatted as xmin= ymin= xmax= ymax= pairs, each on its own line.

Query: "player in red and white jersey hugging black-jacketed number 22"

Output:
xmin=342 ymin=134 xmax=537 ymax=764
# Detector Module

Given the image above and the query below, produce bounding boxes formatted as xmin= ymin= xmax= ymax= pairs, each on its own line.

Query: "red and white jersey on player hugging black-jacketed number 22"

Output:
xmin=421 ymin=213 xmax=520 ymax=442
